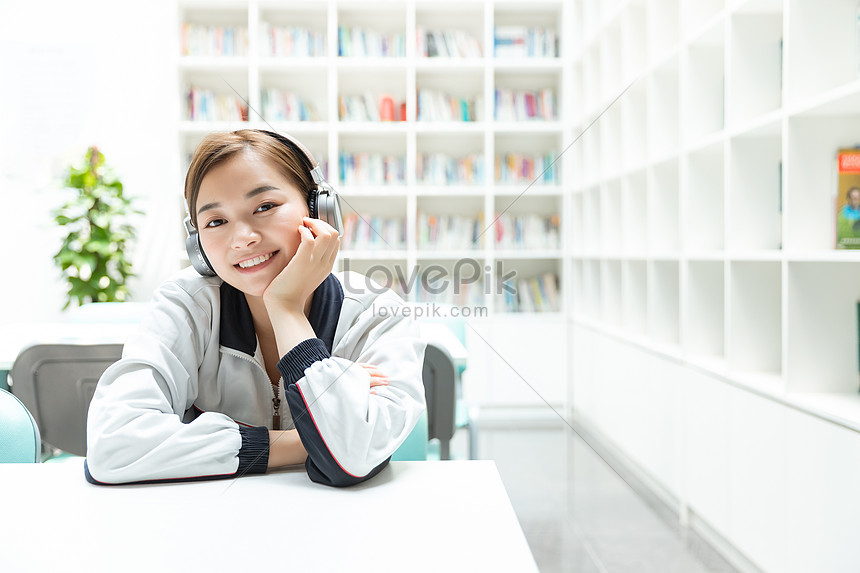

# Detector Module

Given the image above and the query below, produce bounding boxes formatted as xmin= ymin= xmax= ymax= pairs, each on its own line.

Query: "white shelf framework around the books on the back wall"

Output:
xmin=177 ymin=0 xmax=572 ymax=407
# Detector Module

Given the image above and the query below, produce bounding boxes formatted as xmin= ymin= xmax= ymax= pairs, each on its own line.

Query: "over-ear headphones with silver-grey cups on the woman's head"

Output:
xmin=183 ymin=129 xmax=343 ymax=277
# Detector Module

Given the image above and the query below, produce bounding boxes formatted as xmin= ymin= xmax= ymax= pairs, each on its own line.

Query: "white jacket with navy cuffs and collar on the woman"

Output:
xmin=85 ymin=268 xmax=425 ymax=485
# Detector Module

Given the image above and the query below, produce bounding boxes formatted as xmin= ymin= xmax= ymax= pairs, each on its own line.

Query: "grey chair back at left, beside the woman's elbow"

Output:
xmin=12 ymin=344 xmax=122 ymax=456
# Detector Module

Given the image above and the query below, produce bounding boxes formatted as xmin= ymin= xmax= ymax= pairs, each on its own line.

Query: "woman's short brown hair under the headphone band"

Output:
xmin=185 ymin=129 xmax=314 ymax=228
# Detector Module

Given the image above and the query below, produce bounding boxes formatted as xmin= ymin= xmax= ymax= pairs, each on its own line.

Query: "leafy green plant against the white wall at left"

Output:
xmin=52 ymin=147 xmax=142 ymax=310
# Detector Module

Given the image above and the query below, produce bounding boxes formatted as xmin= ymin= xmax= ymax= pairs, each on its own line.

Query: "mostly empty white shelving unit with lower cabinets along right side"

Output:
xmin=566 ymin=0 xmax=860 ymax=572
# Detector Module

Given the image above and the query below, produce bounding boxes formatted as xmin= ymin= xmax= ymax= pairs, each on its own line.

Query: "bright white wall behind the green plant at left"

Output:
xmin=0 ymin=0 xmax=182 ymax=324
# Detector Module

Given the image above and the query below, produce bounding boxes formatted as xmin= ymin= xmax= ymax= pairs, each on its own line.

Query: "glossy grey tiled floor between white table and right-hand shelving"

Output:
xmin=452 ymin=421 xmax=736 ymax=573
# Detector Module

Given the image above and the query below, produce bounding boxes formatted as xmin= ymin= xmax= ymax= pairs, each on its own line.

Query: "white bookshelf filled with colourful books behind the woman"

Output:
xmin=177 ymin=0 xmax=574 ymax=406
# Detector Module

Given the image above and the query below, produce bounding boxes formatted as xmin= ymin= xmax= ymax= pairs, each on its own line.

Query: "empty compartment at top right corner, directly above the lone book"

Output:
xmin=785 ymin=0 xmax=860 ymax=107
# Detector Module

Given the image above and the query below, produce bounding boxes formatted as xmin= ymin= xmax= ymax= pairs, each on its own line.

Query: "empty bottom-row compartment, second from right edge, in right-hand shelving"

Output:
xmin=726 ymin=261 xmax=784 ymax=376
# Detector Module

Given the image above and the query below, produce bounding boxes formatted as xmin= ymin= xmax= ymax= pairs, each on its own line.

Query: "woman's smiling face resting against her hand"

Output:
xmin=196 ymin=149 xmax=308 ymax=296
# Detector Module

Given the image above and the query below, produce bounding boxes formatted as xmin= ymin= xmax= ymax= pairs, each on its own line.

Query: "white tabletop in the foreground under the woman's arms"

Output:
xmin=0 ymin=460 xmax=537 ymax=573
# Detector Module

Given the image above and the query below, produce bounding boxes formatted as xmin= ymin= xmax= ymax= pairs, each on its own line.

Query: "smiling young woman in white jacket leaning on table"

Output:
xmin=85 ymin=130 xmax=425 ymax=486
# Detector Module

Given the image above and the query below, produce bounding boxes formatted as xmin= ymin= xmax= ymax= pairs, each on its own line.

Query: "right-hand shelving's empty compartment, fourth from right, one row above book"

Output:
xmin=647 ymin=58 xmax=679 ymax=160
